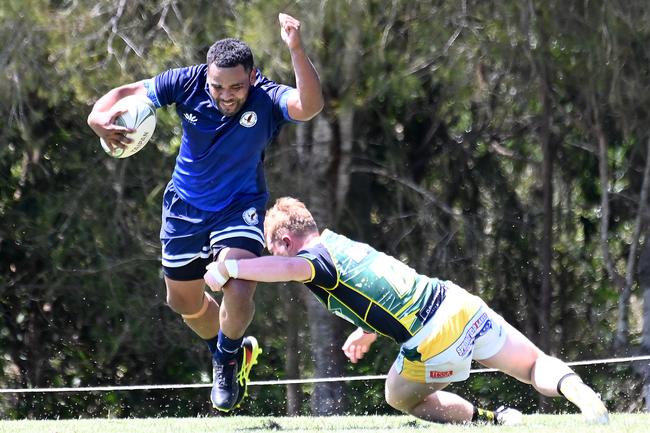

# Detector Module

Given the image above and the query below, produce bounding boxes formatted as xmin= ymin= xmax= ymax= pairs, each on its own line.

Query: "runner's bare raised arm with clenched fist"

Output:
xmin=278 ymin=13 xmax=324 ymax=120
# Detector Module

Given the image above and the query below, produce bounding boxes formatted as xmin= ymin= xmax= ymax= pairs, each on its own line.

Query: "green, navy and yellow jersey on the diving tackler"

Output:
xmin=298 ymin=230 xmax=445 ymax=343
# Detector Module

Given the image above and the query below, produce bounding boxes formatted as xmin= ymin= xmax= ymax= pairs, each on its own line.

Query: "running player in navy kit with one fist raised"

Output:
xmin=88 ymin=14 xmax=323 ymax=411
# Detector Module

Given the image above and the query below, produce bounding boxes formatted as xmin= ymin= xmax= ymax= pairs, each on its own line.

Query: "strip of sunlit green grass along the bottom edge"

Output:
xmin=0 ymin=414 xmax=650 ymax=433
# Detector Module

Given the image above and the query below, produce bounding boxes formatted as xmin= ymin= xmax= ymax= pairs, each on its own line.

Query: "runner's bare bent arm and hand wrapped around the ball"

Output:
xmin=88 ymin=81 xmax=147 ymax=150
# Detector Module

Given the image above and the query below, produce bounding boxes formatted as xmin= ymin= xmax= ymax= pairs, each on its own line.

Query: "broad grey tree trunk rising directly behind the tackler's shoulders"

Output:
xmin=300 ymin=2 xmax=365 ymax=415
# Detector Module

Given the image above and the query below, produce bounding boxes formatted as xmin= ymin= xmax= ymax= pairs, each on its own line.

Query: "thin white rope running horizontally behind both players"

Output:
xmin=0 ymin=355 xmax=650 ymax=394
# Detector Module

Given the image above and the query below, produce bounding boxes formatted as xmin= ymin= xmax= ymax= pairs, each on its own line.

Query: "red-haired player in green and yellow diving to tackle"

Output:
xmin=205 ymin=197 xmax=609 ymax=424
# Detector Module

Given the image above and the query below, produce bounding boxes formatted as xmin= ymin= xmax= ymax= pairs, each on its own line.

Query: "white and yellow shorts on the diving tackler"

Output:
xmin=393 ymin=281 xmax=506 ymax=383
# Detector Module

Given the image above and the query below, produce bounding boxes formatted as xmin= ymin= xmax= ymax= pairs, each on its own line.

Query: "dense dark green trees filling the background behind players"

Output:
xmin=0 ymin=0 xmax=650 ymax=418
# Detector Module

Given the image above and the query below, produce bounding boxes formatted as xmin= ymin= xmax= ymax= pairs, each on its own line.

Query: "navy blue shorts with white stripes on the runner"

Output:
xmin=160 ymin=182 xmax=268 ymax=281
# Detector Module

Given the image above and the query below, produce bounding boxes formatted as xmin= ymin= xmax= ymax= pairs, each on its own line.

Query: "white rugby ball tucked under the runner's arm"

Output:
xmin=99 ymin=95 xmax=156 ymax=158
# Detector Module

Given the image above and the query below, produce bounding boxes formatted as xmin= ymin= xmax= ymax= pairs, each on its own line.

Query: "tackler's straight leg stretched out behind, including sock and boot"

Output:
xmin=479 ymin=324 xmax=609 ymax=424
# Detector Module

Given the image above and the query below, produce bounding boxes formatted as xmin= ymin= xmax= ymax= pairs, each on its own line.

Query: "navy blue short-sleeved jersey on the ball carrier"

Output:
xmin=144 ymin=64 xmax=292 ymax=211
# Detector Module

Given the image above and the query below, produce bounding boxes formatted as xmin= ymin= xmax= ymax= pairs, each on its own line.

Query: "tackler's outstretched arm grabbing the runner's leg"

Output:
xmin=203 ymin=256 xmax=312 ymax=291
